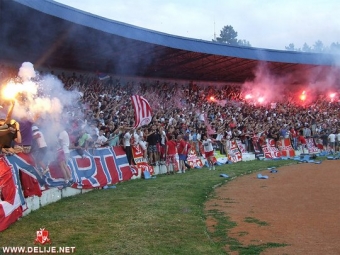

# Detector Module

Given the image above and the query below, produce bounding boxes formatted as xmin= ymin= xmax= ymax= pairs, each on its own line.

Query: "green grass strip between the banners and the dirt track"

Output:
xmin=0 ymin=160 xmax=295 ymax=255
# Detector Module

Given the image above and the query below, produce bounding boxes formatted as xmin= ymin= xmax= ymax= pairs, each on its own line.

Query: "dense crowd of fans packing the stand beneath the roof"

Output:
xmin=0 ymin=63 xmax=340 ymax=176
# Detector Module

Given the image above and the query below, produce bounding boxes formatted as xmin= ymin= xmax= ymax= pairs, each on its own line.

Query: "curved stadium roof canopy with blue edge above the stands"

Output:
xmin=0 ymin=0 xmax=339 ymax=83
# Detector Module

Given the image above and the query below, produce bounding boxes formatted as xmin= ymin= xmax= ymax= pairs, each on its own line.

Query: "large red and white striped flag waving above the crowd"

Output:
xmin=131 ymin=95 xmax=152 ymax=128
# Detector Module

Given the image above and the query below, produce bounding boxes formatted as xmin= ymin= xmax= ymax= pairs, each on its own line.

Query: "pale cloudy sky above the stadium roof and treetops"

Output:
xmin=57 ymin=0 xmax=340 ymax=50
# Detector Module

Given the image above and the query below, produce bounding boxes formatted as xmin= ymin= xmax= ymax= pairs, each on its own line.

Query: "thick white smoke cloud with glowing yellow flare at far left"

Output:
xmin=2 ymin=62 xmax=81 ymax=156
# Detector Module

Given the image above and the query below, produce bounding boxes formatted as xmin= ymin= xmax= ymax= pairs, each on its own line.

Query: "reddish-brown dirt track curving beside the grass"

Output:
xmin=206 ymin=160 xmax=340 ymax=255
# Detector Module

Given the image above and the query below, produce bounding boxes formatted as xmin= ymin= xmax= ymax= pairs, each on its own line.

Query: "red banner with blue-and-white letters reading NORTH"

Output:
xmin=4 ymin=146 xmax=137 ymax=190
